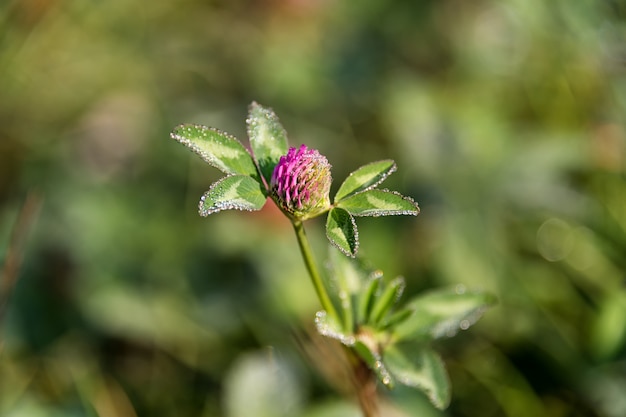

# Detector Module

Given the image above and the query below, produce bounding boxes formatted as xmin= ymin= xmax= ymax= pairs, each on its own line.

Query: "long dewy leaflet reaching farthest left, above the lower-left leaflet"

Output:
xmin=170 ymin=124 xmax=258 ymax=178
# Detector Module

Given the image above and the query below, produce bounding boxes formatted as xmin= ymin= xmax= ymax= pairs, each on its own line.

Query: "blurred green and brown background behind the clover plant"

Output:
xmin=0 ymin=0 xmax=626 ymax=417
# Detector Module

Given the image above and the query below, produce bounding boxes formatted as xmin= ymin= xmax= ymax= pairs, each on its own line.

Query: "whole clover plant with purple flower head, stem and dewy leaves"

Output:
xmin=171 ymin=103 xmax=495 ymax=417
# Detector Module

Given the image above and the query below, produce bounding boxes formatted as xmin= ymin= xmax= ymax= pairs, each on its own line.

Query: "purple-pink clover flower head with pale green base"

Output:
xmin=270 ymin=145 xmax=332 ymax=219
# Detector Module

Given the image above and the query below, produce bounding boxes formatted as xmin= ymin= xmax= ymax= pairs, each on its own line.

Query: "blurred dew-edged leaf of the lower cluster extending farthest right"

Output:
xmin=393 ymin=286 xmax=496 ymax=340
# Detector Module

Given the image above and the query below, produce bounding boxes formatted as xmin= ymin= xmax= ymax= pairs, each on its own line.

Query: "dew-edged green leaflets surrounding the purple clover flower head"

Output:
xmin=171 ymin=103 xmax=419 ymax=257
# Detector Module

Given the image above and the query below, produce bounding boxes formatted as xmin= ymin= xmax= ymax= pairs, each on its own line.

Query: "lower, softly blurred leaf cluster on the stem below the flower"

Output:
xmin=315 ymin=253 xmax=495 ymax=408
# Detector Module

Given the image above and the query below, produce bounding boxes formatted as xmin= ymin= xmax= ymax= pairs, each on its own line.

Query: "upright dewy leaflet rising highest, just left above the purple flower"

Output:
xmin=246 ymin=102 xmax=288 ymax=184
